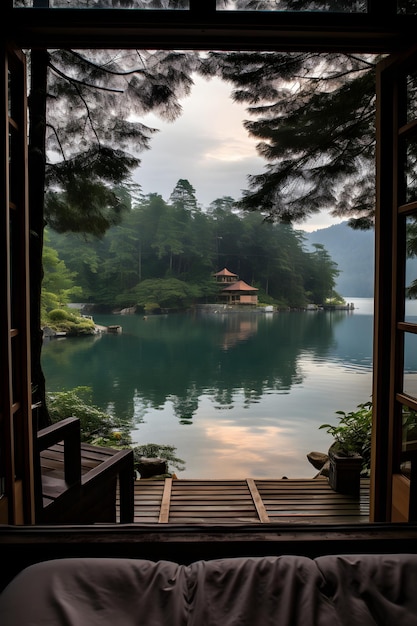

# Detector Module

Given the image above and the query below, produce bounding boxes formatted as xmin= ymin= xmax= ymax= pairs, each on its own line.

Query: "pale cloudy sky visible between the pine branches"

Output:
xmin=134 ymin=77 xmax=341 ymax=231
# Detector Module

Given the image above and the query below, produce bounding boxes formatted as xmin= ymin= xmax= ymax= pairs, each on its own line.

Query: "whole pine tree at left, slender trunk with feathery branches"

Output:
xmin=29 ymin=49 xmax=196 ymax=426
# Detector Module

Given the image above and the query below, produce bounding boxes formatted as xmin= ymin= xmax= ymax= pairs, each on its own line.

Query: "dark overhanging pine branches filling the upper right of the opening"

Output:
xmin=202 ymin=52 xmax=376 ymax=227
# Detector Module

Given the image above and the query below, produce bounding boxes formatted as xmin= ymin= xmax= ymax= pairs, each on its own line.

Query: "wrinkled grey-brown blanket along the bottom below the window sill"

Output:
xmin=0 ymin=555 xmax=417 ymax=626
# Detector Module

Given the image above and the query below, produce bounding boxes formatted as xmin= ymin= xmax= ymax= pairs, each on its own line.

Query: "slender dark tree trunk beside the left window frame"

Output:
xmin=28 ymin=50 xmax=50 ymax=428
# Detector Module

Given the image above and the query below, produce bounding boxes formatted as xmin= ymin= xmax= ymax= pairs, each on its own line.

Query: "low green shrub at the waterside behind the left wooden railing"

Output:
xmin=47 ymin=387 xmax=131 ymax=448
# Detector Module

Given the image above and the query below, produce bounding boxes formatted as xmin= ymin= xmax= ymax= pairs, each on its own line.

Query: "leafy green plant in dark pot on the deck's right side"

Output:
xmin=320 ymin=402 xmax=372 ymax=496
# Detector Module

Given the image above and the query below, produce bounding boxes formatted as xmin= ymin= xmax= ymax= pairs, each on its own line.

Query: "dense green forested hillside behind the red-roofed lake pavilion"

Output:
xmin=48 ymin=180 xmax=337 ymax=310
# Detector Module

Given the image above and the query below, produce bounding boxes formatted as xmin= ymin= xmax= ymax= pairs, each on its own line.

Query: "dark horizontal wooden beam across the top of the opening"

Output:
xmin=4 ymin=2 xmax=417 ymax=53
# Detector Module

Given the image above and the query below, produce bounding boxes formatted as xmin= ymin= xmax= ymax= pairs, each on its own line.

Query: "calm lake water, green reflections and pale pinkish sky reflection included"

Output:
xmin=39 ymin=298 xmax=417 ymax=478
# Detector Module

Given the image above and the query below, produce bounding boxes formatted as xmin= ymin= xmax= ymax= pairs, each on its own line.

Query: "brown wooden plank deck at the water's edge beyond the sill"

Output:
xmin=128 ymin=478 xmax=369 ymax=524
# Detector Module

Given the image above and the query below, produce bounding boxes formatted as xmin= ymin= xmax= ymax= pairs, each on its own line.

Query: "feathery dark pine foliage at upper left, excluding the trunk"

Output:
xmin=41 ymin=49 xmax=197 ymax=236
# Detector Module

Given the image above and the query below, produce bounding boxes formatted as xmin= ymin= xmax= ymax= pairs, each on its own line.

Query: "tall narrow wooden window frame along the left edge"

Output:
xmin=0 ymin=49 xmax=34 ymax=524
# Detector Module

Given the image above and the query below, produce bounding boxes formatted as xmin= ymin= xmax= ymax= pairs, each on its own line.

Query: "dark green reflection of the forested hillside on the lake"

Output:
xmin=44 ymin=312 xmax=345 ymax=423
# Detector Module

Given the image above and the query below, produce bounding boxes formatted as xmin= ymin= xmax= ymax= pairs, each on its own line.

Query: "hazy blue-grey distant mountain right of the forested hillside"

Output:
xmin=304 ymin=222 xmax=375 ymax=298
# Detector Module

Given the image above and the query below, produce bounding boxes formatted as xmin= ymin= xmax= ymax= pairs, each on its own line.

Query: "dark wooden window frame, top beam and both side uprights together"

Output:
xmin=0 ymin=0 xmax=417 ymax=523
